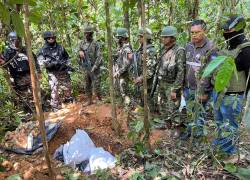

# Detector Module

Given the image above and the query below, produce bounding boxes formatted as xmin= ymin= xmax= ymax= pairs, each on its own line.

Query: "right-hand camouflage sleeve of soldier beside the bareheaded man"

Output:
xmin=172 ymin=50 xmax=186 ymax=91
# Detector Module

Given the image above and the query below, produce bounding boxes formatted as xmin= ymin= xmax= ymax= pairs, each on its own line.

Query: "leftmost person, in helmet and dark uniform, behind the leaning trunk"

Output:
xmin=2 ymin=32 xmax=40 ymax=113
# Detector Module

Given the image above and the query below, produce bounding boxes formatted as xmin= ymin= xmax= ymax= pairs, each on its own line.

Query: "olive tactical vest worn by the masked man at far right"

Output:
xmin=218 ymin=42 xmax=250 ymax=92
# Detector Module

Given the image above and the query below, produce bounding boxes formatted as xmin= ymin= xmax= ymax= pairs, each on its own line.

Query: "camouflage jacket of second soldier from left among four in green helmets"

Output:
xmin=115 ymin=44 xmax=132 ymax=76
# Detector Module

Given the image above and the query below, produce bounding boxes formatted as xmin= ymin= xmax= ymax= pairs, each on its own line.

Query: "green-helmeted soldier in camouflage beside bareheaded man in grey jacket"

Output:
xmin=156 ymin=26 xmax=185 ymax=125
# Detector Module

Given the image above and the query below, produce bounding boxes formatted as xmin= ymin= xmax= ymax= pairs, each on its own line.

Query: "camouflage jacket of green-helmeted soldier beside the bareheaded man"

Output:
xmin=158 ymin=44 xmax=186 ymax=91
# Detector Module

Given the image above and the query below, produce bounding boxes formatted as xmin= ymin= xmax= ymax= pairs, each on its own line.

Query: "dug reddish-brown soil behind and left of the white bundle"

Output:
xmin=0 ymin=97 xmax=131 ymax=180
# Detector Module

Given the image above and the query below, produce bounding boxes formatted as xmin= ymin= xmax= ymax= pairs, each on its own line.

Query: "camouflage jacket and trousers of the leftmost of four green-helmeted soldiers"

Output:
xmin=79 ymin=40 xmax=103 ymax=98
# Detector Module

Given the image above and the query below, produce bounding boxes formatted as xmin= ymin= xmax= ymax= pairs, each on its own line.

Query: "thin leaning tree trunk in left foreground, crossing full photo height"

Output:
xmin=24 ymin=0 xmax=54 ymax=179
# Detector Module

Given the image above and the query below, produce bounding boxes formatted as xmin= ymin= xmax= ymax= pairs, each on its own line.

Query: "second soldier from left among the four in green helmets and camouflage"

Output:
xmin=114 ymin=28 xmax=133 ymax=106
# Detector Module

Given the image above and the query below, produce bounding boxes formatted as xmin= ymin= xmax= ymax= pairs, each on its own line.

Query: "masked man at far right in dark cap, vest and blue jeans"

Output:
xmin=213 ymin=16 xmax=250 ymax=155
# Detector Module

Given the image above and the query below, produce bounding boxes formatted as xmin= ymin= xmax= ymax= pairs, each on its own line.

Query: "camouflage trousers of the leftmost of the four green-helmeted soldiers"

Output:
xmin=84 ymin=73 xmax=101 ymax=97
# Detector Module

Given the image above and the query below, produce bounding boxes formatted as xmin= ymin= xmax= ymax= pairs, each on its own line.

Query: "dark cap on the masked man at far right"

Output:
xmin=222 ymin=16 xmax=246 ymax=31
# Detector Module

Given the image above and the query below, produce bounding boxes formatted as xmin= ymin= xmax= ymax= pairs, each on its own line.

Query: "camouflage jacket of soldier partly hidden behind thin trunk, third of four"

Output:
xmin=133 ymin=44 xmax=157 ymax=80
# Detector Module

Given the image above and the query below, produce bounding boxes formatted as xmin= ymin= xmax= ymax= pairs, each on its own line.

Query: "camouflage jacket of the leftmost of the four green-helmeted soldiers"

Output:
xmin=79 ymin=40 xmax=103 ymax=72
